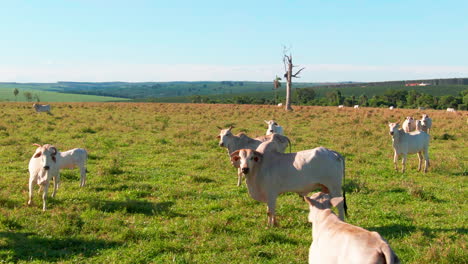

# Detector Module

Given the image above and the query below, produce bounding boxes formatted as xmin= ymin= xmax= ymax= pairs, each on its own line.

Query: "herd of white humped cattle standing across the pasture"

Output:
xmin=28 ymin=104 xmax=438 ymax=263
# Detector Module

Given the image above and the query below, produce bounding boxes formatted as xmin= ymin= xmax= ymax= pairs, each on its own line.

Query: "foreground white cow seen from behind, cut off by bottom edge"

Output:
xmin=304 ymin=192 xmax=400 ymax=264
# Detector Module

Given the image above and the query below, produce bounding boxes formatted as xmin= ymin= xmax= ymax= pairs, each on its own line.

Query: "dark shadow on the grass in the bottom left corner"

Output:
xmin=0 ymin=232 xmax=121 ymax=262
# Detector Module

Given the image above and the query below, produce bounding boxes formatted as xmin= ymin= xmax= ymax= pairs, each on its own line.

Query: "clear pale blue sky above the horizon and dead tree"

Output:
xmin=0 ymin=0 xmax=468 ymax=82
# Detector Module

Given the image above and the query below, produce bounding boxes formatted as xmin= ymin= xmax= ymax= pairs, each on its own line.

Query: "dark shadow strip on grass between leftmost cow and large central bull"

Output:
xmin=90 ymin=199 xmax=186 ymax=217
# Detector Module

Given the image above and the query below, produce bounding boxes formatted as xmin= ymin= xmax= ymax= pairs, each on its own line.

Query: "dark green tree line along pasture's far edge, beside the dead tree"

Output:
xmin=190 ymin=88 xmax=468 ymax=110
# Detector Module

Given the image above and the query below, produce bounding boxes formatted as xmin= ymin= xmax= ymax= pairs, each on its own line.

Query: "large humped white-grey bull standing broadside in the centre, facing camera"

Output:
xmin=231 ymin=141 xmax=347 ymax=226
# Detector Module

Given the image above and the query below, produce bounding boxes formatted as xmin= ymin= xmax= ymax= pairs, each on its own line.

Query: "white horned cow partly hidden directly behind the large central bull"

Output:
xmin=218 ymin=126 xmax=291 ymax=186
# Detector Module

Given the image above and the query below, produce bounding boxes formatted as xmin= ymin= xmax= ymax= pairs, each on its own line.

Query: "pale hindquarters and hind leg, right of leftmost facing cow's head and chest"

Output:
xmin=58 ymin=148 xmax=88 ymax=187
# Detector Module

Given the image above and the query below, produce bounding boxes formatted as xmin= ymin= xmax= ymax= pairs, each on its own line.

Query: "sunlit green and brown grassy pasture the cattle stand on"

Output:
xmin=0 ymin=103 xmax=468 ymax=264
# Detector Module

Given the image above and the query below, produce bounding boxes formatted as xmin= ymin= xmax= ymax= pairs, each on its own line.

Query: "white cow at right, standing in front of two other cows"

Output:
xmin=388 ymin=123 xmax=429 ymax=172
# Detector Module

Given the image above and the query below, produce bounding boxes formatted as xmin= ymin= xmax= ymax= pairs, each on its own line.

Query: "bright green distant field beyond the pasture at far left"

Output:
xmin=0 ymin=87 xmax=128 ymax=102
